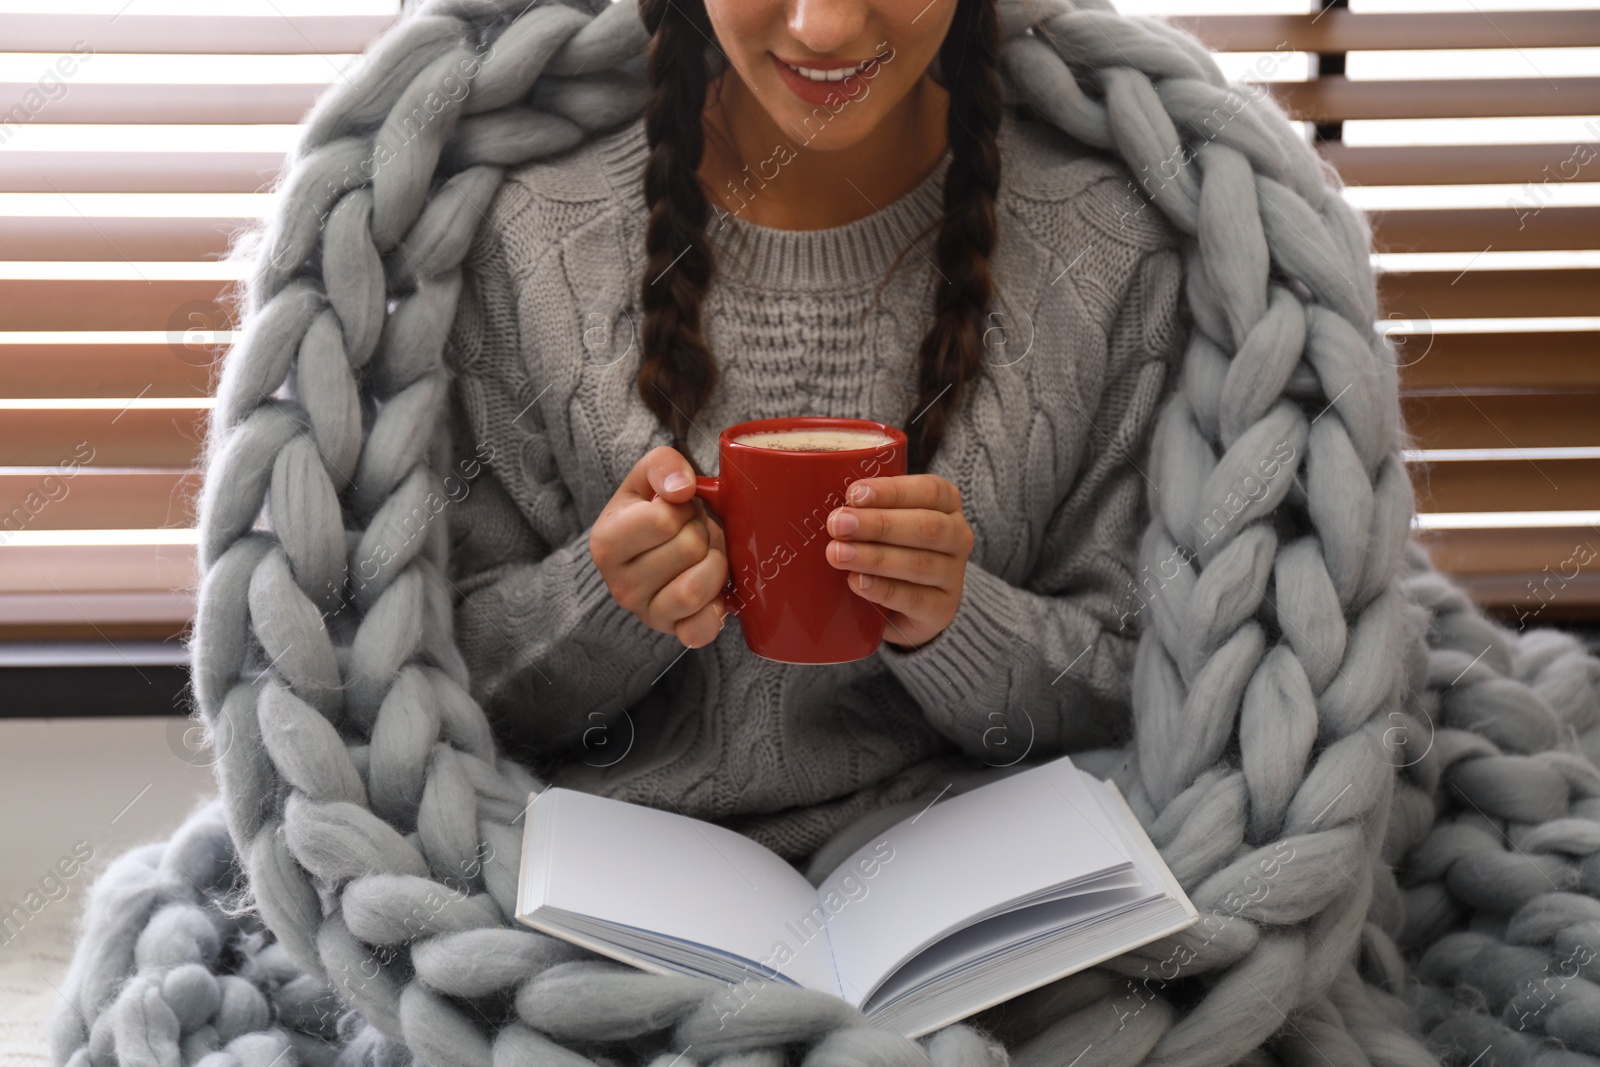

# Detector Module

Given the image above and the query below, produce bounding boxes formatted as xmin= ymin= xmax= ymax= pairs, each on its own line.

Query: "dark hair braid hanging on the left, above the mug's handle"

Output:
xmin=638 ymin=0 xmax=717 ymax=472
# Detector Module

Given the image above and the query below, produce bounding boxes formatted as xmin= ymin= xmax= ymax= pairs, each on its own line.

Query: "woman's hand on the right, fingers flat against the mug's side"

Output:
xmin=827 ymin=474 xmax=973 ymax=651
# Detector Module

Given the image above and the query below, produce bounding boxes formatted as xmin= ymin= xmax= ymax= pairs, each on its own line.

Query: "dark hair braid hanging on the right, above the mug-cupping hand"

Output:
xmin=906 ymin=0 xmax=1002 ymax=472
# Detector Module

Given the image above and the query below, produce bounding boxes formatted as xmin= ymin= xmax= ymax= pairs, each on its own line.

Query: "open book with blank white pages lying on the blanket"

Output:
xmin=517 ymin=757 xmax=1200 ymax=1037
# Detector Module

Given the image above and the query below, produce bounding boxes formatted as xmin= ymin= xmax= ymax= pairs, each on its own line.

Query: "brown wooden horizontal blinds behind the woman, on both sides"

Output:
xmin=0 ymin=0 xmax=1600 ymax=638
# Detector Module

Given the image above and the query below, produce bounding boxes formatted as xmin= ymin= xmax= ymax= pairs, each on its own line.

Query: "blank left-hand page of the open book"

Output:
xmin=517 ymin=787 xmax=838 ymax=993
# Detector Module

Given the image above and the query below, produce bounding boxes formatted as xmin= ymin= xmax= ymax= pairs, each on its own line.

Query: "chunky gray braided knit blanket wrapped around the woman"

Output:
xmin=53 ymin=0 xmax=1600 ymax=1067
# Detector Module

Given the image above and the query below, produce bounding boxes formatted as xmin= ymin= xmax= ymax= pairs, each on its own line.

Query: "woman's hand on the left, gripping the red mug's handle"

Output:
xmin=589 ymin=445 xmax=728 ymax=648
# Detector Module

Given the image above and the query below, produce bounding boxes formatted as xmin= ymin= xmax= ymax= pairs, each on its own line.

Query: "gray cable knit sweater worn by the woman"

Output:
xmin=446 ymin=109 xmax=1187 ymax=861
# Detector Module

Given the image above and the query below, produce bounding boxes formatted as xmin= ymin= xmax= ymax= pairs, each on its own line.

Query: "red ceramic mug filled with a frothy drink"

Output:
xmin=694 ymin=416 xmax=906 ymax=664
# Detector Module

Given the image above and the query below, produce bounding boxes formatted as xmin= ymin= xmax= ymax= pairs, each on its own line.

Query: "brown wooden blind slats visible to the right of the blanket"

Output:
xmin=1171 ymin=0 xmax=1600 ymax=625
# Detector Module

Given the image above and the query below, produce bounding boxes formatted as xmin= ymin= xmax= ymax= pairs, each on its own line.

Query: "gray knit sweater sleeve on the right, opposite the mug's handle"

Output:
xmin=878 ymin=246 xmax=1186 ymax=765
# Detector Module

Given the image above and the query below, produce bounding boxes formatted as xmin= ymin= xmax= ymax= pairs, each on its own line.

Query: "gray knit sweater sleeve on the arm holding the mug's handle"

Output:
xmin=446 ymin=191 xmax=683 ymax=757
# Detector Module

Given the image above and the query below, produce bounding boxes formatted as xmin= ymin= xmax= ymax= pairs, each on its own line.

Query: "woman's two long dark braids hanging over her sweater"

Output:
xmin=637 ymin=0 xmax=1002 ymax=472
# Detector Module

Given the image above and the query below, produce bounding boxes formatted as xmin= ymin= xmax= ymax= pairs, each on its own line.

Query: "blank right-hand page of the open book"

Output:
xmin=816 ymin=757 xmax=1131 ymax=1006
